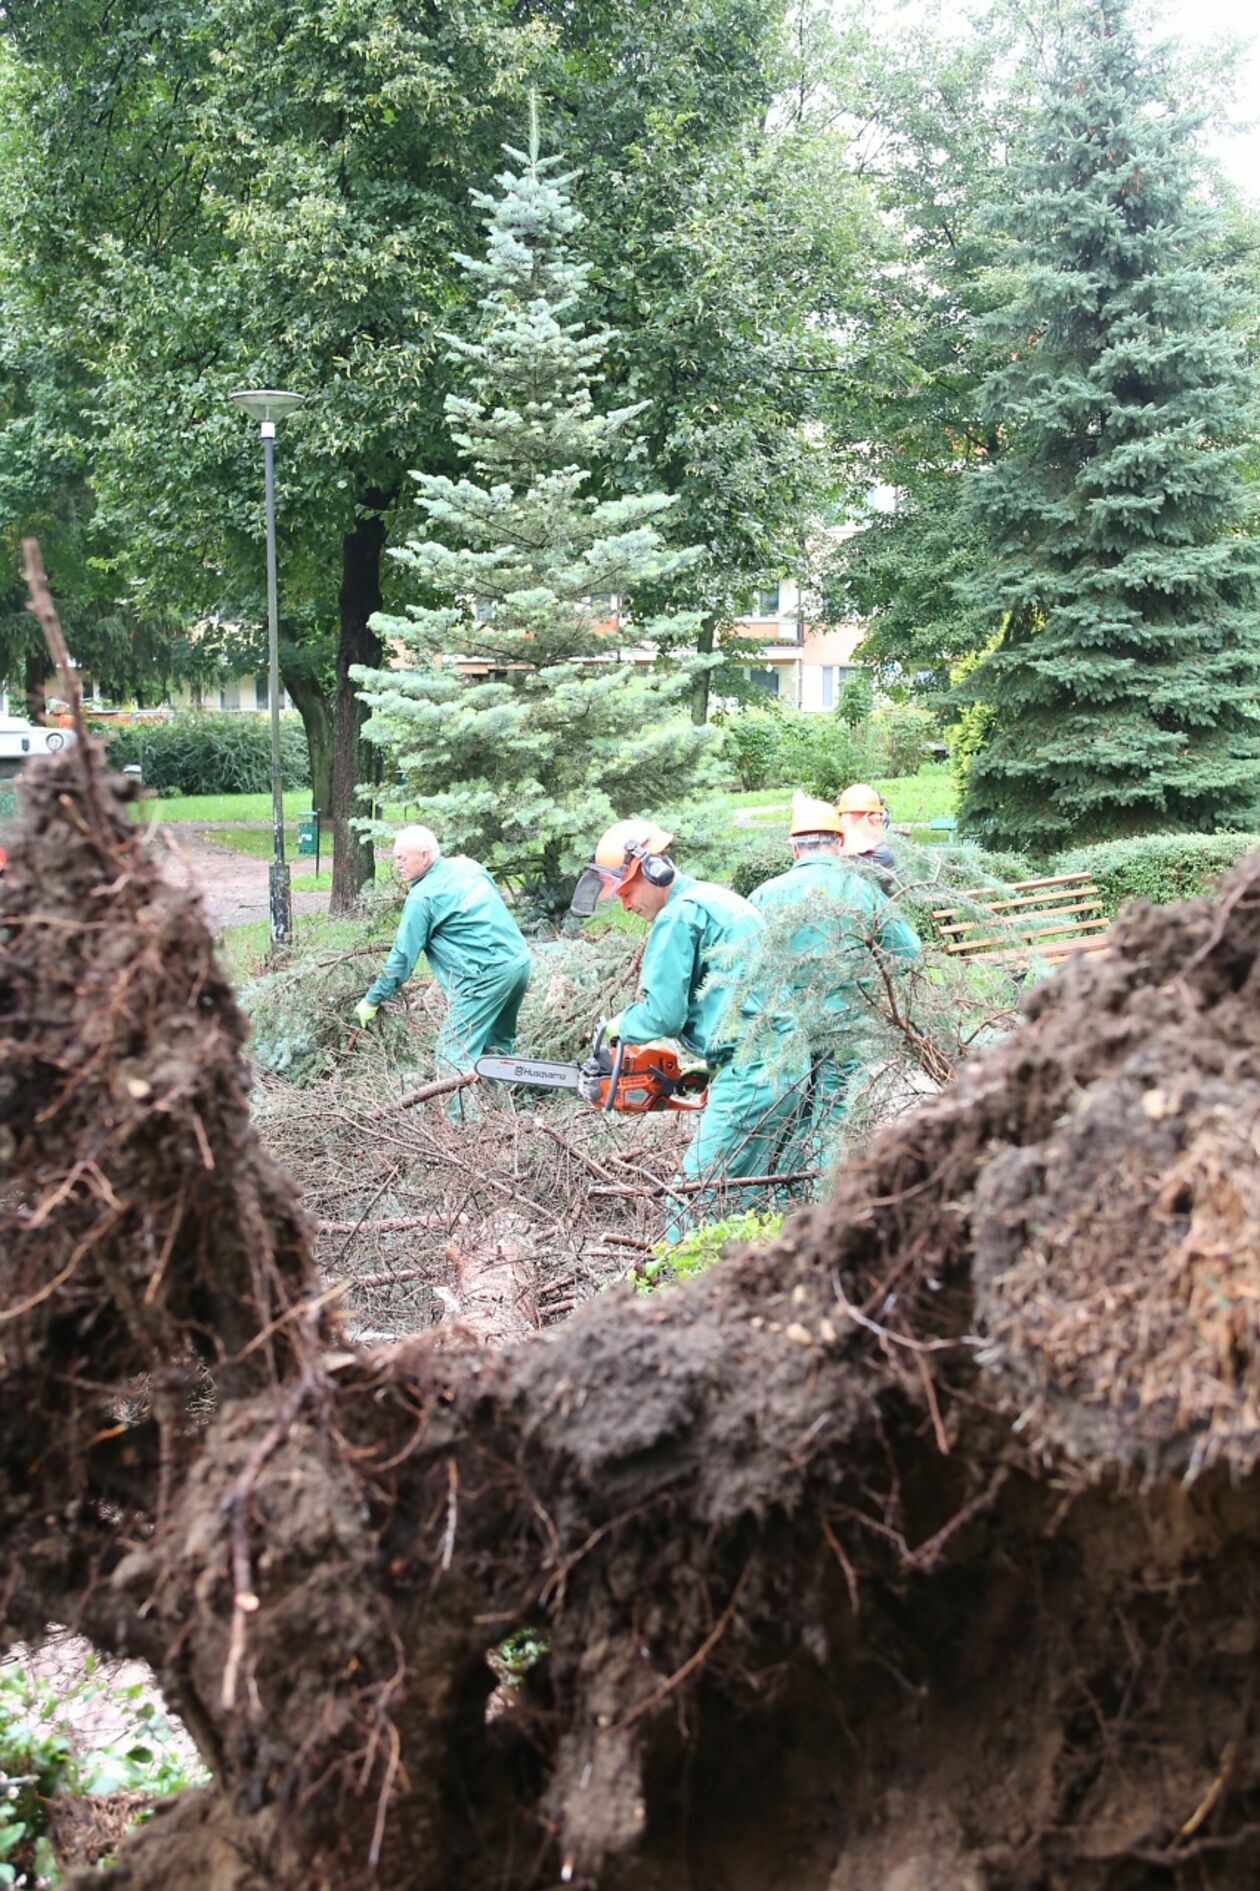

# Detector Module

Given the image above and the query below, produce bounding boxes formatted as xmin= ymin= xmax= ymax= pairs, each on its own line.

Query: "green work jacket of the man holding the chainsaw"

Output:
xmin=617 ymin=874 xmax=762 ymax=1063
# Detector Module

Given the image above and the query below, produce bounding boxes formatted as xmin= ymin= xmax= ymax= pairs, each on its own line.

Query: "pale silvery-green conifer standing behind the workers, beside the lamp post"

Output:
xmin=356 ymin=108 xmax=713 ymax=906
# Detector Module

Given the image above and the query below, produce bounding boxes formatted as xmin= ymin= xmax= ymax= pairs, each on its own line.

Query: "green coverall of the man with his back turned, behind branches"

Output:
xmin=749 ymin=853 xmax=919 ymax=1171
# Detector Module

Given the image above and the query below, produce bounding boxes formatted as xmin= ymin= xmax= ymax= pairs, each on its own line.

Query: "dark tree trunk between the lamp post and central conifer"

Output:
xmin=329 ymin=512 xmax=386 ymax=913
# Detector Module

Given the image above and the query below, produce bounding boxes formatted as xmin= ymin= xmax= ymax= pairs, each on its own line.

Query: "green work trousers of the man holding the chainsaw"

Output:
xmin=666 ymin=1065 xmax=800 ymax=1240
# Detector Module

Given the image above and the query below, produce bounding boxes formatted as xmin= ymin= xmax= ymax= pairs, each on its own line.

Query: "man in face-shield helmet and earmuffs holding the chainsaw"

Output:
xmin=571 ymin=821 xmax=804 ymax=1240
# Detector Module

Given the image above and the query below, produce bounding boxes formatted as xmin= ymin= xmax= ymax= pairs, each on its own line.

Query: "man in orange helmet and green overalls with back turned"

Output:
xmin=751 ymin=792 xmax=919 ymax=1171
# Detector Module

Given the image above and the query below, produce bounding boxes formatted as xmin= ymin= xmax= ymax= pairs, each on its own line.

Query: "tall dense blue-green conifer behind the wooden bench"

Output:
xmin=961 ymin=0 xmax=1260 ymax=851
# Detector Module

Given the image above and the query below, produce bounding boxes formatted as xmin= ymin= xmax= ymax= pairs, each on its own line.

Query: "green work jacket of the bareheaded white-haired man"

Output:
xmin=367 ymin=855 xmax=530 ymax=1004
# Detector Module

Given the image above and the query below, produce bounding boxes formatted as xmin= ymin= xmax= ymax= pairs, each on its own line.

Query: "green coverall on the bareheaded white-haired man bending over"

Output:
xmin=367 ymin=855 xmax=530 ymax=1101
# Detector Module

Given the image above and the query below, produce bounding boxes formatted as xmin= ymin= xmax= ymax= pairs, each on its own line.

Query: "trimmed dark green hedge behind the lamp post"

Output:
xmin=104 ymin=711 xmax=310 ymax=794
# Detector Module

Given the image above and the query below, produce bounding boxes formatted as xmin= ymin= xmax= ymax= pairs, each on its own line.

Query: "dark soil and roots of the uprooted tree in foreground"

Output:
xmin=0 ymin=751 xmax=1260 ymax=1891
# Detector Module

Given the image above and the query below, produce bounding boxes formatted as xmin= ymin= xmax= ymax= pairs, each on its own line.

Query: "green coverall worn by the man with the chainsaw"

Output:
xmin=609 ymin=874 xmax=804 ymax=1240
